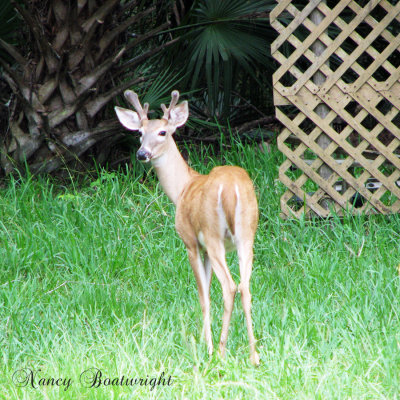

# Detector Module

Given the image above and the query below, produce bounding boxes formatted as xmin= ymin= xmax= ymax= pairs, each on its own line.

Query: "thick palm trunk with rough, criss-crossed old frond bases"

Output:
xmin=0 ymin=0 xmax=174 ymax=174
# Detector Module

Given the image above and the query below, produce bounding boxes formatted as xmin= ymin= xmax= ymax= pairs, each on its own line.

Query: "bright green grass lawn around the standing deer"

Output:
xmin=0 ymin=145 xmax=400 ymax=400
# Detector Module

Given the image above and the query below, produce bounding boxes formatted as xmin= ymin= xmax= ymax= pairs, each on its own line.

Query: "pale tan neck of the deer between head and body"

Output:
xmin=152 ymin=140 xmax=200 ymax=205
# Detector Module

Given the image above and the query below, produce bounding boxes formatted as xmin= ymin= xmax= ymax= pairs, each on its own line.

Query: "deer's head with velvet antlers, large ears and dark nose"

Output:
xmin=115 ymin=90 xmax=189 ymax=162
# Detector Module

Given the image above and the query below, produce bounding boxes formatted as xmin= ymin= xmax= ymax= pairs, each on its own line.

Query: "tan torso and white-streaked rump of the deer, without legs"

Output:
xmin=176 ymin=166 xmax=258 ymax=250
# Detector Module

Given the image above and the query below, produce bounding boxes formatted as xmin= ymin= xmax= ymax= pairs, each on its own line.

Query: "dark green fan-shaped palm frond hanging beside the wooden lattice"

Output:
xmin=169 ymin=0 xmax=276 ymax=122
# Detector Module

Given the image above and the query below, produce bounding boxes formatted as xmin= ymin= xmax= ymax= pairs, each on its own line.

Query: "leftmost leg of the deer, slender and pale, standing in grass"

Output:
xmin=188 ymin=245 xmax=213 ymax=355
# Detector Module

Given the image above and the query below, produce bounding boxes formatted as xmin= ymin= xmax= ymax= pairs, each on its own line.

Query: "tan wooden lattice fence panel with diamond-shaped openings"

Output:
xmin=271 ymin=0 xmax=400 ymax=217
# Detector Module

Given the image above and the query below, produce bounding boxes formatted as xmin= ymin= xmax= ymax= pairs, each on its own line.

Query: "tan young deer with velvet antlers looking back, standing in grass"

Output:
xmin=115 ymin=90 xmax=260 ymax=366
